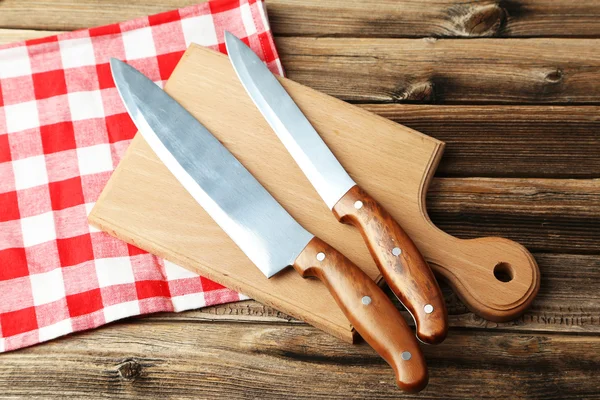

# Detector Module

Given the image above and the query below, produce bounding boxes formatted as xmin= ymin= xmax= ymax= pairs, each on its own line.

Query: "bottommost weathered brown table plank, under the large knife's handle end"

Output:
xmin=0 ymin=320 xmax=600 ymax=400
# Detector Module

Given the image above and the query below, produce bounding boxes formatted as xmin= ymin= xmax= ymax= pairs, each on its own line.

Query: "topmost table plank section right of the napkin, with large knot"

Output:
xmin=269 ymin=0 xmax=600 ymax=38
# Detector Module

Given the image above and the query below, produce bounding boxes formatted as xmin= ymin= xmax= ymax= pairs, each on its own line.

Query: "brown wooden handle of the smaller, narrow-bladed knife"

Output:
xmin=333 ymin=185 xmax=448 ymax=344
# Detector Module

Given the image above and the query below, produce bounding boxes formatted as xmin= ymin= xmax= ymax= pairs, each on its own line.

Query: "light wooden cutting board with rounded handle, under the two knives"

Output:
xmin=89 ymin=45 xmax=539 ymax=341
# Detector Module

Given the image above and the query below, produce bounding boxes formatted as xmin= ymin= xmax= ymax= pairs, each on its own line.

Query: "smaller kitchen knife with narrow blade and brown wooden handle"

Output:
xmin=225 ymin=32 xmax=448 ymax=344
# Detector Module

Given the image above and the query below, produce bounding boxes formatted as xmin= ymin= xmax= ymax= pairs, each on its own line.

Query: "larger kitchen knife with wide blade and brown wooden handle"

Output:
xmin=111 ymin=59 xmax=428 ymax=392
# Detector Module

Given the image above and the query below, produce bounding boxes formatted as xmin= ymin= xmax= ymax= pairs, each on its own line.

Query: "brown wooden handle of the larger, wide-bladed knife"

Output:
xmin=294 ymin=237 xmax=428 ymax=392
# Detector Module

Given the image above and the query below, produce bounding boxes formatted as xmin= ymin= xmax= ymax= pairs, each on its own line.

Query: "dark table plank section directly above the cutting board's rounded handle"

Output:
xmin=427 ymin=178 xmax=600 ymax=253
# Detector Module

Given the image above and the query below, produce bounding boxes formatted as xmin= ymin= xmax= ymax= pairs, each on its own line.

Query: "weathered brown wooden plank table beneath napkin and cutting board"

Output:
xmin=0 ymin=0 xmax=600 ymax=399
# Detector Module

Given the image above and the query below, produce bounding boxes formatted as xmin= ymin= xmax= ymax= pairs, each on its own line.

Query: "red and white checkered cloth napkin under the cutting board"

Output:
xmin=0 ymin=0 xmax=283 ymax=352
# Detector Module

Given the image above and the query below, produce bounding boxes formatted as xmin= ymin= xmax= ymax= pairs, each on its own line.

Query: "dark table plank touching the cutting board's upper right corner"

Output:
xmin=361 ymin=104 xmax=600 ymax=178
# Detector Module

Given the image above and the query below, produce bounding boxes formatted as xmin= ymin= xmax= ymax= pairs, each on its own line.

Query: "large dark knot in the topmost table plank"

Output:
xmin=449 ymin=3 xmax=507 ymax=37
